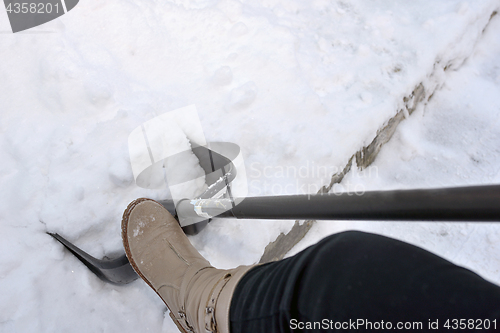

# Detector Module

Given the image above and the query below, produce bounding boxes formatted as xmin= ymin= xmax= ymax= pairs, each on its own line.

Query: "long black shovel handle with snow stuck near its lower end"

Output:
xmin=173 ymin=185 xmax=500 ymax=222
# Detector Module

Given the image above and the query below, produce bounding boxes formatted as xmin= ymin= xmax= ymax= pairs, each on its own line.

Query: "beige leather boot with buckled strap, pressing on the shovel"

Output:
xmin=122 ymin=198 xmax=253 ymax=333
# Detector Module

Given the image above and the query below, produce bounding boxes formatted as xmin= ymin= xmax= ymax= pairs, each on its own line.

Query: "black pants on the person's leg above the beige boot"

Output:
xmin=230 ymin=231 xmax=500 ymax=333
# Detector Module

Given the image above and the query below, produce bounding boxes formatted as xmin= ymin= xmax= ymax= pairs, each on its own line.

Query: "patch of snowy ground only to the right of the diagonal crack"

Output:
xmin=290 ymin=13 xmax=500 ymax=284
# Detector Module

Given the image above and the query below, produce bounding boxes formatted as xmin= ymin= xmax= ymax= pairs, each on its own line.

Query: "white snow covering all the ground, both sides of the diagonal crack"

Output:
xmin=0 ymin=0 xmax=500 ymax=332
